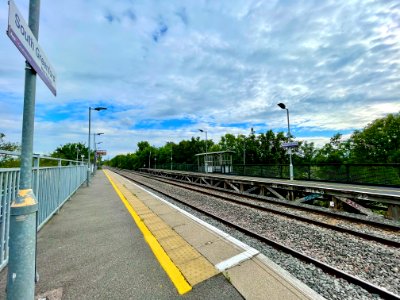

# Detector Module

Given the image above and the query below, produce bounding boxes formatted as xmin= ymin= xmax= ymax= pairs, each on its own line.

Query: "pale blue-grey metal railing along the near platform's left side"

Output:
xmin=0 ymin=150 xmax=87 ymax=270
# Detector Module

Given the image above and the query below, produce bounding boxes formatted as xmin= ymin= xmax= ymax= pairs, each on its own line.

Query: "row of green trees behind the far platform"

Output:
xmin=106 ymin=114 xmax=400 ymax=169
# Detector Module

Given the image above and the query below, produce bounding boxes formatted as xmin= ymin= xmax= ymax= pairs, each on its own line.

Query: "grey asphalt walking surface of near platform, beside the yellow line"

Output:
xmin=0 ymin=171 xmax=243 ymax=300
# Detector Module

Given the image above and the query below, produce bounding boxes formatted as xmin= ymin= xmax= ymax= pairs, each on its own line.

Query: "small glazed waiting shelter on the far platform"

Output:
xmin=195 ymin=150 xmax=235 ymax=174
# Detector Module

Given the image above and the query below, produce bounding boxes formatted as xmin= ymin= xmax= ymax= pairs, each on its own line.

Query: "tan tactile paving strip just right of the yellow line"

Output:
xmin=104 ymin=173 xmax=218 ymax=286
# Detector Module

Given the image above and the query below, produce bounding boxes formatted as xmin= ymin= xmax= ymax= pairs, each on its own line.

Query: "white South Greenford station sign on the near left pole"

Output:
xmin=7 ymin=0 xmax=57 ymax=96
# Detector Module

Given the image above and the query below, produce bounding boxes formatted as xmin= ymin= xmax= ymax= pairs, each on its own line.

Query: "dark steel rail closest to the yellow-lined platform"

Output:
xmin=114 ymin=170 xmax=400 ymax=300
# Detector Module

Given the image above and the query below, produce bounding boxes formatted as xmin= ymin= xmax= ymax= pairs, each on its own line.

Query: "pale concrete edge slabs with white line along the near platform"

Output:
xmin=106 ymin=171 xmax=324 ymax=300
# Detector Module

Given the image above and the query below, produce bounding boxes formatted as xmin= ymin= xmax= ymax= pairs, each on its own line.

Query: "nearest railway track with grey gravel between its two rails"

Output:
xmin=111 ymin=171 xmax=400 ymax=299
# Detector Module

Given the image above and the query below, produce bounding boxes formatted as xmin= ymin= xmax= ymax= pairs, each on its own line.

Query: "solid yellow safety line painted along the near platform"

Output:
xmin=103 ymin=170 xmax=192 ymax=295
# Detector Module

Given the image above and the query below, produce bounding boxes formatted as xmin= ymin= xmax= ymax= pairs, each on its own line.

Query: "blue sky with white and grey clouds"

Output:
xmin=0 ymin=0 xmax=400 ymax=158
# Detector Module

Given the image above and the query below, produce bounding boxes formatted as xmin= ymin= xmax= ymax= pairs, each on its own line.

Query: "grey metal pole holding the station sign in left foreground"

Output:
xmin=7 ymin=0 xmax=40 ymax=300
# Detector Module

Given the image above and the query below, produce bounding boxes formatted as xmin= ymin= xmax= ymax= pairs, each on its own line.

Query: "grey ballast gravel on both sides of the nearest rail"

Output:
xmin=123 ymin=174 xmax=400 ymax=299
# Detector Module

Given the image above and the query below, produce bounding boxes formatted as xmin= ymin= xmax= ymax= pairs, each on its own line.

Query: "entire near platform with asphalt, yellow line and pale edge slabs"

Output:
xmin=0 ymin=171 xmax=323 ymax=299
